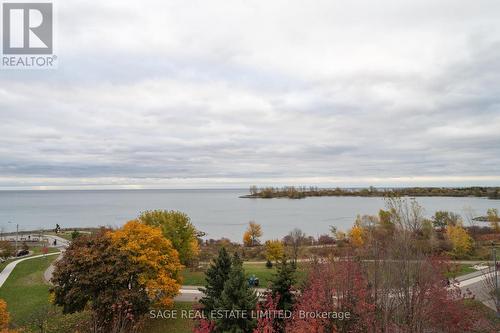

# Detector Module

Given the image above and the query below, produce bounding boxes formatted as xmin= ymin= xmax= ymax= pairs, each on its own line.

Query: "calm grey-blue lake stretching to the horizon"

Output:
xmin=0 ymin=190 xmax=500 ymax=241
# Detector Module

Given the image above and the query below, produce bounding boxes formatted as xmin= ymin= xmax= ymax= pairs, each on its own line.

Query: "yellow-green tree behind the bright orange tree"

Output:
xmin=138 ymin=210 xmax=200 ymax=265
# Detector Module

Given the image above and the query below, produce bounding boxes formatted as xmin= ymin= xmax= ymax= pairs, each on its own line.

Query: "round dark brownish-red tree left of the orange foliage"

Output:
xmin=51 ymin=230 xmax=142 ymax=332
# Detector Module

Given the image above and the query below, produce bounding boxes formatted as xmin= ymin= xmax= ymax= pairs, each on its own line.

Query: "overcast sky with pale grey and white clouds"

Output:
xmin=0 ymin=0 xmax=500 ymax=189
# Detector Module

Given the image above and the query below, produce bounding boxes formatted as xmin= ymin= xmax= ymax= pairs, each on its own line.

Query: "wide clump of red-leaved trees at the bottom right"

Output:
xmin=286 ymin=257 xmax=486 ymax=333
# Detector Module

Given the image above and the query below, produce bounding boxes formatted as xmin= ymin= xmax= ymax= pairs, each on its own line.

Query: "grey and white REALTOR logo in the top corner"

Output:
xmin=2 ymin=0 xmax=57 ymax=69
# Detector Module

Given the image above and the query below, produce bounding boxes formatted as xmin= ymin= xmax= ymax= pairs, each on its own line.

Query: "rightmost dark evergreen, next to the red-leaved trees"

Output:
xmin=271 ymin=257 xmax=296 ymax=311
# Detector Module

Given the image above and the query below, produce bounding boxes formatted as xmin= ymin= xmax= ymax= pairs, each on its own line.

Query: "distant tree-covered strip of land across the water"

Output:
xmin=240 ymin=186 xmax=500 ymax=199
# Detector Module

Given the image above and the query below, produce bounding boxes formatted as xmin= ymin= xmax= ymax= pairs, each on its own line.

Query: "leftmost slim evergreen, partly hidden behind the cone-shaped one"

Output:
xmin=200 ymin=247 xmax=231 ymax=316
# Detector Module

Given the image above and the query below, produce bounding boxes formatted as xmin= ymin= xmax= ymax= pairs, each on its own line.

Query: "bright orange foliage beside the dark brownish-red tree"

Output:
xmin=110 ymin=221 xmax=183 ymax=306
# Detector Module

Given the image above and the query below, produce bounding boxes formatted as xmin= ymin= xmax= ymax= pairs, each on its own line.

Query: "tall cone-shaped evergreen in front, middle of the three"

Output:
xmin=215 ymin=253 xmax=257 ymax=333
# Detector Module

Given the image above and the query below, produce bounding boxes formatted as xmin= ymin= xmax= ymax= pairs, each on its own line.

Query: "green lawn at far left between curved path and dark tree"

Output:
xmin=0 ymin=255 xmax=57 ymax=325
